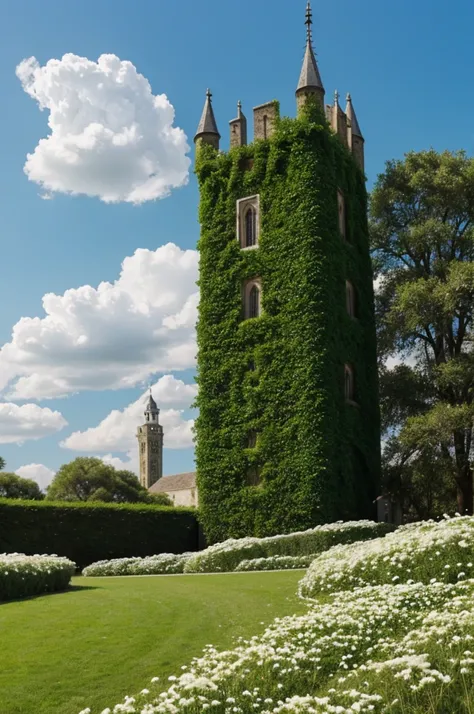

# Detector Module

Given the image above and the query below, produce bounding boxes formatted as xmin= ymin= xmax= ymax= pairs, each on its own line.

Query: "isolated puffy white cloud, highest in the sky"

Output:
xmin=16 ymin=53 xmax=190 ymax=204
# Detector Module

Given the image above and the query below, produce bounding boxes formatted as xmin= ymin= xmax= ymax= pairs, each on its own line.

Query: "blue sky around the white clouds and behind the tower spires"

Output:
xmin=0 ymin=0 xmax=474 ymax=484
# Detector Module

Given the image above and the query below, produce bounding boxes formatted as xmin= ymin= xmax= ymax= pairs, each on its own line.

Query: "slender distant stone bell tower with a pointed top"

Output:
xmin=137 ymin=389 xmax=163 ymax=488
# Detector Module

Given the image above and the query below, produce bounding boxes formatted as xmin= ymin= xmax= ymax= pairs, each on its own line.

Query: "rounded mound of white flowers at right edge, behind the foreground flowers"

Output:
xmin=300 ymin=516 xmax=474 ymax=597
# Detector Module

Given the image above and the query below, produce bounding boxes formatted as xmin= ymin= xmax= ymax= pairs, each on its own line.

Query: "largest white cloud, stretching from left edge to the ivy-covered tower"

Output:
xmin=0 ymin=243 xmax=199 ymax=400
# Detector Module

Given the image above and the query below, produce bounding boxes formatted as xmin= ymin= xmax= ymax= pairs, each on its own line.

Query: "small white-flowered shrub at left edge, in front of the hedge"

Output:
xmin=0 ymin=553 xmax=76 ymax=600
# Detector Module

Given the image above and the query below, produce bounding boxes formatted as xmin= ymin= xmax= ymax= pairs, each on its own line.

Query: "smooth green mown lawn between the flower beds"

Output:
xmin=0 ymin=571 xmax=305 ymax=714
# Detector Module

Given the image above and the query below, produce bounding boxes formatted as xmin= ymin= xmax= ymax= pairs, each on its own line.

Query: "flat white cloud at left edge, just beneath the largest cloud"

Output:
xmin=0 ymin=402 xmax=67 ymax=444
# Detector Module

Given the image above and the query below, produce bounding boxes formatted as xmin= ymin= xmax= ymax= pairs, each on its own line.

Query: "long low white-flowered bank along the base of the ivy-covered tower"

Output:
xmin=184 ymin=521 xmax=393 ymax=573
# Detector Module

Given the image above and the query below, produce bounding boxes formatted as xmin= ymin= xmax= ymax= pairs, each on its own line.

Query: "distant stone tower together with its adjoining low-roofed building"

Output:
xmin=137 ymin=389 xmax=198 ymax=507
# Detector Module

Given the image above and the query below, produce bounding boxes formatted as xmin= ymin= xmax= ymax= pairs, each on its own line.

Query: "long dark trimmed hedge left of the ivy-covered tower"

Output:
xmin=0 ymin=499 xmax=198 ymax=568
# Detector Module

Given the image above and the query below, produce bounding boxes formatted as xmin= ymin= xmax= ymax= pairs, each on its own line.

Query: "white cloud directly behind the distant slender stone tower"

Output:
xmin=60 ymin=375 xmax=197 ymax=454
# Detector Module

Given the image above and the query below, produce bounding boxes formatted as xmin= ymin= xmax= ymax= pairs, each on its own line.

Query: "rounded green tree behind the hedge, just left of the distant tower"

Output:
xmin=46 ymin=456 xmax=165 ymax=503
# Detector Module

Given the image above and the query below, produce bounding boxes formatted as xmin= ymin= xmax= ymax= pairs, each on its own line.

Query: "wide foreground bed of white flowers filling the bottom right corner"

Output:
xmin=93 ymin=580 xmax=474 ymax=714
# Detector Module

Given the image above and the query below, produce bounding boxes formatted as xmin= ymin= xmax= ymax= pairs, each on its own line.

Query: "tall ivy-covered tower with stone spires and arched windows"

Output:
xmin=196 ymin=3 xmax=380 ymax=541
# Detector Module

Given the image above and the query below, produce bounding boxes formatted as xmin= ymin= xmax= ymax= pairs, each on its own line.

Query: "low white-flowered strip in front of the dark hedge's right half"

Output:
xmin=82 ymin=553 xmax=191 ymax=577
